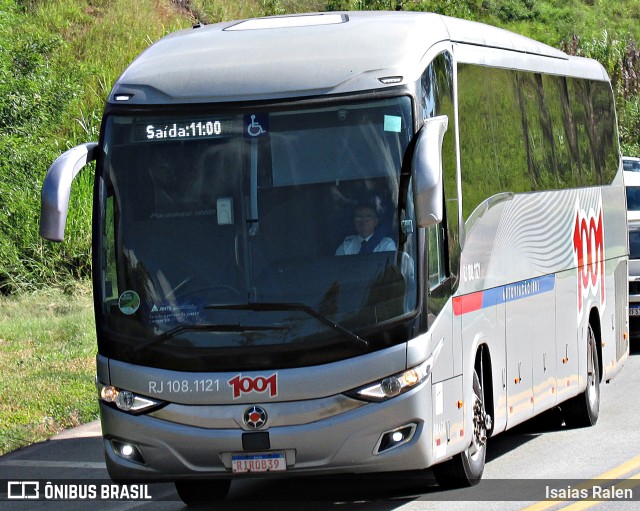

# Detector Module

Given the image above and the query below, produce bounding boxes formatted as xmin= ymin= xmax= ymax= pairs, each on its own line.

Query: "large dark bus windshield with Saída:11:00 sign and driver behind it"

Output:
xmin=97 ymin=97 xmax=417 ymax=371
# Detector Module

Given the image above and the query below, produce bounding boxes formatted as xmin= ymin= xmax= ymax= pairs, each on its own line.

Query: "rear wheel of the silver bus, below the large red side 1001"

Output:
xmin=560 ymin=323 xmax=600 ymax=428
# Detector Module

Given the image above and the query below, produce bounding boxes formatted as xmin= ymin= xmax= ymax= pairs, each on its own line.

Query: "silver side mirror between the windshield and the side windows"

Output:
xmin=411 ymin=115 xmax=449 ymax=227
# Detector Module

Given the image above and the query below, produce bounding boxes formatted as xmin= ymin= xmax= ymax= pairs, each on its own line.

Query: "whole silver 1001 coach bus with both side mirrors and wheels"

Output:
xmin=41 ymin=12 xmax=629 ymax=503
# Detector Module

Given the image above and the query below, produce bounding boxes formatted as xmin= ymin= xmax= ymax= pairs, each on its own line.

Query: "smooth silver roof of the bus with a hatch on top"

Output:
xmin=109 ymin=11 xmax=606 ymax=105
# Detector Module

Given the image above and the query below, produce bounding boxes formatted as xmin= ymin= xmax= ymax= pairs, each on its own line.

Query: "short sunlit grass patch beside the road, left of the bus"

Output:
xmin=0 ymin=282 xmax=98 ymax=454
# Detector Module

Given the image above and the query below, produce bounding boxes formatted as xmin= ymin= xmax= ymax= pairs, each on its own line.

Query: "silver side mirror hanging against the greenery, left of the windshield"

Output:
xmin=40 ymin=142 xmax=98 ymax=241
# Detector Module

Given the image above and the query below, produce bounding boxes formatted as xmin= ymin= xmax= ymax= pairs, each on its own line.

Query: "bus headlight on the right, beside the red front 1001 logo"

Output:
xmin=349 ymin=339 xmax=443 ymax=403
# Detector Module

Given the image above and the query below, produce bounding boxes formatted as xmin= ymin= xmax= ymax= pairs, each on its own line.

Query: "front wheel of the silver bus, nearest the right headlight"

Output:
xmin=433 ymin=371 xmax=491 ymax=488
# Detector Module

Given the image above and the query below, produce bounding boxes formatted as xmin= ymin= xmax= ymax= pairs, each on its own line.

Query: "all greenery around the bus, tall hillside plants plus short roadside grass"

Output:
xmin=0 ymin=0 xmax=640 ymax=452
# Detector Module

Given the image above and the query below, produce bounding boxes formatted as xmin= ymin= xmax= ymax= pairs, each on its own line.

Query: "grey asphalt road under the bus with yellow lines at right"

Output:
xmin=0 ymin=346 xmax=640 ymax=511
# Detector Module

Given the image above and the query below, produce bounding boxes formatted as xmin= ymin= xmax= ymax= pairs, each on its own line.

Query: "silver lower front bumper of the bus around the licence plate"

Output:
xmin=100 ymin=384 xmax=434 ymax=480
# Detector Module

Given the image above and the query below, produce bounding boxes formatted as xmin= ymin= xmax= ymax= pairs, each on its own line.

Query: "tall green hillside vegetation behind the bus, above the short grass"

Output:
xmin=0 ymin=0 xmax=640 ymax=293
